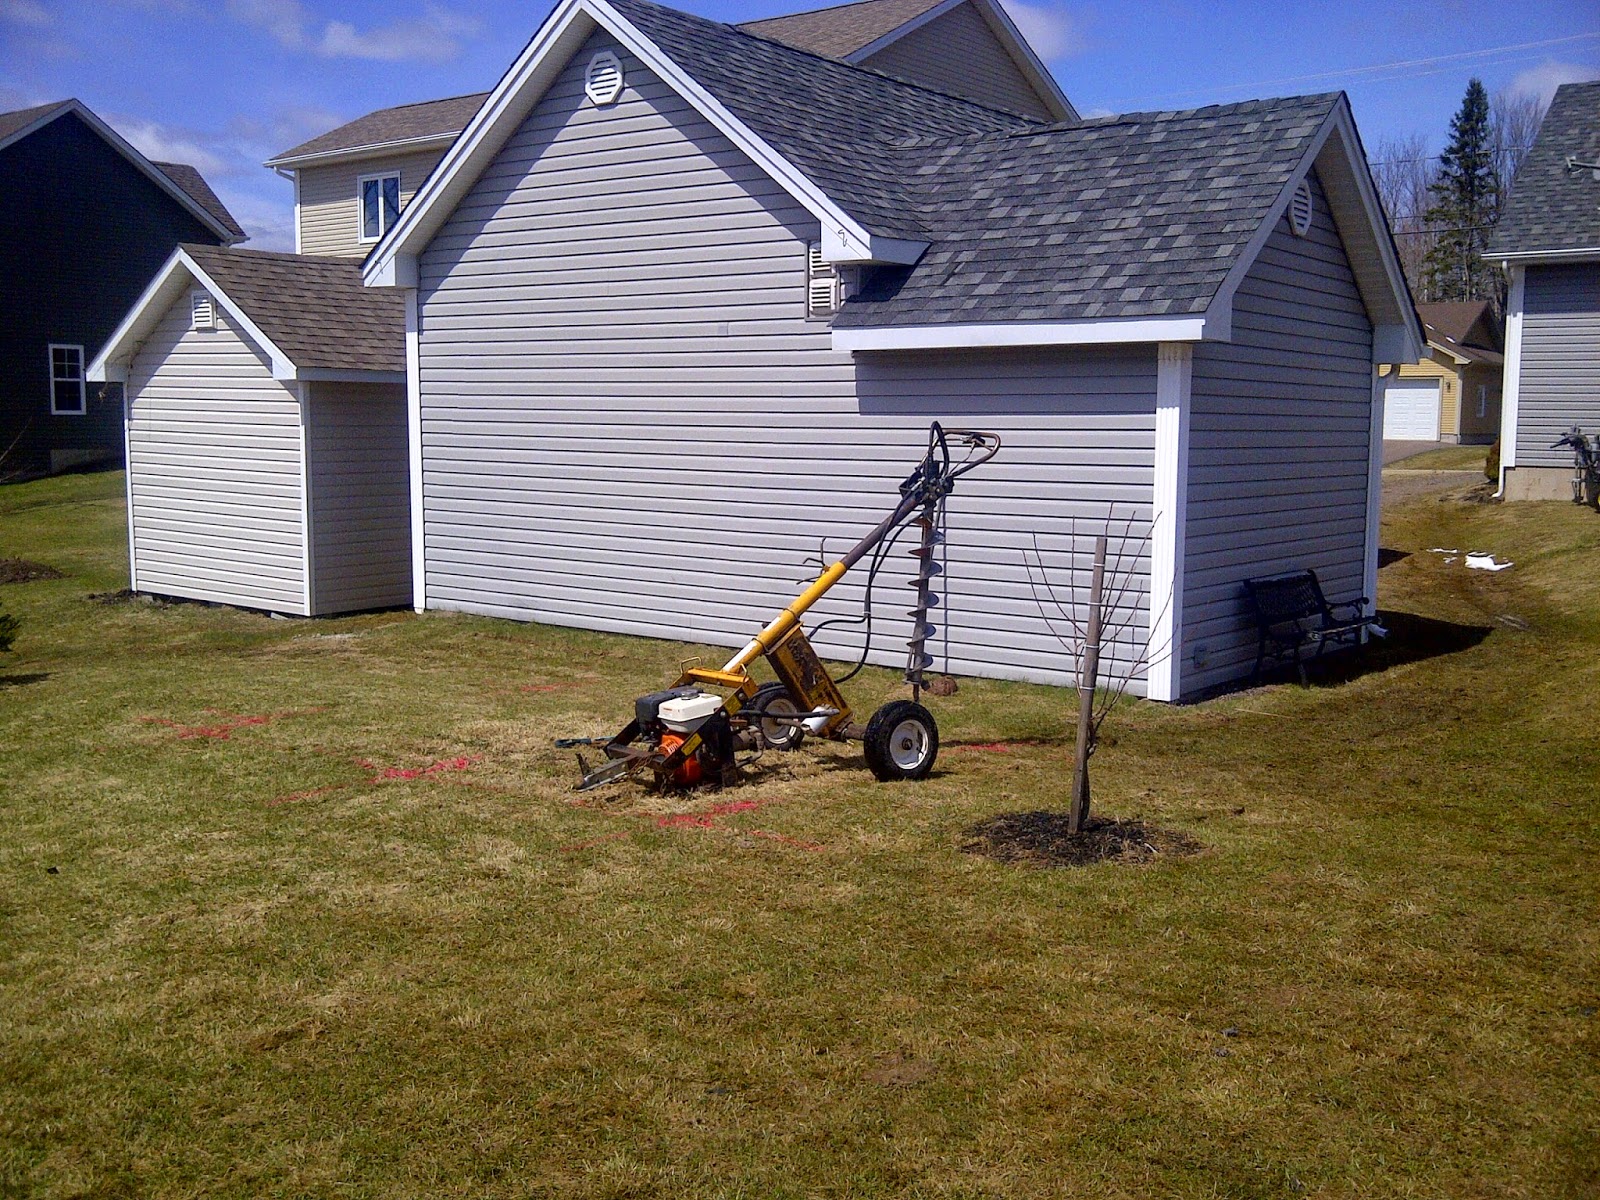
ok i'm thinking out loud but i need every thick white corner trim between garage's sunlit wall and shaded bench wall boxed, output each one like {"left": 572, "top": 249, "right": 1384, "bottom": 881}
{"left": 1144, "top": 342, "right": 1194, "bottom": 701}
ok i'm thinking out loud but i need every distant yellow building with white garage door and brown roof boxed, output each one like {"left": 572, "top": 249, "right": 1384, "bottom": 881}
{"left": 1384, "top": 301, "right": 1506, "bottom": 445}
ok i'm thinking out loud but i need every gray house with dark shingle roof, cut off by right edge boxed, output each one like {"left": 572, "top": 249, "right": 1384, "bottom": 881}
{"left": 1485, "top": 83, "right": 1600, "bottom": 499}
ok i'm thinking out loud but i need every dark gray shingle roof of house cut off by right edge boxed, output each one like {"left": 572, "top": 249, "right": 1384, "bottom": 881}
{"left": 1488, "top": 82, "right": 1600, "bottom": 254}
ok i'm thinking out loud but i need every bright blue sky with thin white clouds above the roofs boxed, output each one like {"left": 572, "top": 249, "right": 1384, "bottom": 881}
{"left": 0, "top": 0, "right": 1600, "bottom": 250}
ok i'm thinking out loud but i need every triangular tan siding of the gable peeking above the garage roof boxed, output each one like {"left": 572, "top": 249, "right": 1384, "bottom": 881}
{"left": 861, "top": 5, "right": 1053, "bottom": 120}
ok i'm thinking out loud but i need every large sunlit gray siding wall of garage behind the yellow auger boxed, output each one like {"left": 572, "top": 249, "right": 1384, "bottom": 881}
{"left": 419, "top": 35, "right": 1155, "bottom": 691}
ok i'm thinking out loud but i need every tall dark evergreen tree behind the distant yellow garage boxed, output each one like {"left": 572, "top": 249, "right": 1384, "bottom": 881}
{"left": 1424, "top": 80, "right": 1499, "bottom": 301}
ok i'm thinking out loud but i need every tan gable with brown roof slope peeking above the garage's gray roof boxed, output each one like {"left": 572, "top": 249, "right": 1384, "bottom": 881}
{"left": 739, "top": 0, "right": 1078, "bottom": 123}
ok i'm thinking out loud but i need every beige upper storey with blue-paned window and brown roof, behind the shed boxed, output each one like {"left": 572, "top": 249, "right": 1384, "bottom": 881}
{"left": 267, "top": 93, "right": 483, "bottom": 258}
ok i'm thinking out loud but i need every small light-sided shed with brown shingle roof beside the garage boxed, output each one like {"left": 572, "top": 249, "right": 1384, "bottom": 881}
{"left": 93, "top": 246, "right": 411, "bottom": 616}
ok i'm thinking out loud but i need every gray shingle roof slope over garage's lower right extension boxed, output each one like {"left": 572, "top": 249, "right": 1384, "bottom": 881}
{"left": 835, "top": 94, "right": 1342, "bottom": 328}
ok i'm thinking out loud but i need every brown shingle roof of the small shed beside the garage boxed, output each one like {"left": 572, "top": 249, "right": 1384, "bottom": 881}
{"left": 182, "top": 245, "right": 405, "bottom": 371}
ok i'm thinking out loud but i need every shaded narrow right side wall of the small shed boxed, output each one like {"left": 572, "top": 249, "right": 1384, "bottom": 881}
{"left": 306, "top": 382, "right": 411, "bottom": 616}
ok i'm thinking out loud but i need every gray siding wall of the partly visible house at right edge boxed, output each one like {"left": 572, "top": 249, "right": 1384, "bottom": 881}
{"left": 1517, "top": 262, "right": 1600, "bottom": 467}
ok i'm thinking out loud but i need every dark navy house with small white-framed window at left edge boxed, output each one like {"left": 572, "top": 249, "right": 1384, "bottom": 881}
{"left": 0, "top": 99, "right": 245, "bottom": 478}
